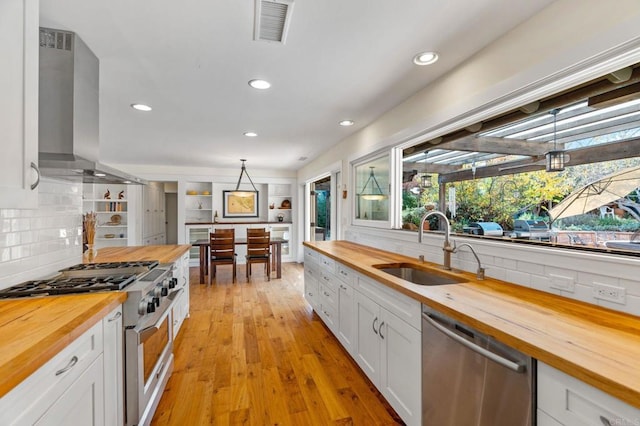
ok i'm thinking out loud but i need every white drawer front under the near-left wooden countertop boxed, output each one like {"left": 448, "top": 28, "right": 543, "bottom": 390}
{"left": 0, "top": 321, "right": 103, "bottom": 425}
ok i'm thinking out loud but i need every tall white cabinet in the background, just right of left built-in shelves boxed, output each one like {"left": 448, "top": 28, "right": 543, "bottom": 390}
{"left": 142, "top": 182, "right": 167, "bottom": 246}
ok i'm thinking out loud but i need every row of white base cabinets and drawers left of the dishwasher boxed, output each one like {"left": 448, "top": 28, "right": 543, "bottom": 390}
{"left": 304, "top": 247, "right": 422, "bottom": 425}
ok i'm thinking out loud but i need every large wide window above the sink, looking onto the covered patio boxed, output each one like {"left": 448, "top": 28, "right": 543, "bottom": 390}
{"left": 398, "top": 64, "right": 640, "bottom": 255}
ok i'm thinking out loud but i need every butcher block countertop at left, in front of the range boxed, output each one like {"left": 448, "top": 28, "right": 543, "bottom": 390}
{"left": 0, "top": 292, "right": 127, "bottom": 397}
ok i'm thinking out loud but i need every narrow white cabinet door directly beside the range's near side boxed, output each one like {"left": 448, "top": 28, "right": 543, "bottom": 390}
{"left": 103, "top": 306, "right": 124, "bottom": 425}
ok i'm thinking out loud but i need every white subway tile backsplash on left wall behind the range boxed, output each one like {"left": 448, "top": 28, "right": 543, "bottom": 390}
{"left": 0, "top": 179, "right": 82, "bottom": 288}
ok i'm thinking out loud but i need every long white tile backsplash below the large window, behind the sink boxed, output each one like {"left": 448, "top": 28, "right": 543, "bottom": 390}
{"left": 345, "top": 226, "right": 640, "bottom": 316}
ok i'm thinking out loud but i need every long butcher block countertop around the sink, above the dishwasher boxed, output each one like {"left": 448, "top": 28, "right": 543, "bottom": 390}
{"left": 304, "top": 241, "right": 640, "bottom": 408}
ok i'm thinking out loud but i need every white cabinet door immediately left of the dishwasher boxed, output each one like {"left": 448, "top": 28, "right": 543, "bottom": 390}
{"left": 379, "top": 308, "right": 422, "bottom": 425}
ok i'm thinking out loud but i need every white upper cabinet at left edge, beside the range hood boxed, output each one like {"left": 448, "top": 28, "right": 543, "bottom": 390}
{"left": 0, "top": 0, "right": 39, "bottom": 209}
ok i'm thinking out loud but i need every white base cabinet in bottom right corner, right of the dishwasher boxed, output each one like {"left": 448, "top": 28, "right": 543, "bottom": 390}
{"left": 537, "top": 362, "right": 640, "bottom": 426}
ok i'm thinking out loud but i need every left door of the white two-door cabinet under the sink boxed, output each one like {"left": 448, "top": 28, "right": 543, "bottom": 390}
{"left": 355, "top": 292, "right": 381, "bottom": 386}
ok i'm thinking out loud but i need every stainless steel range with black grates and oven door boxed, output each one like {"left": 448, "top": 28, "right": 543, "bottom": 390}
{"left": 0, "top": 261, "right": 184, "bottom": 426}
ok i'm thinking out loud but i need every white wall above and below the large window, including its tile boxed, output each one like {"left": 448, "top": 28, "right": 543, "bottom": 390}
{"left": 298, "top": 0, "right": 640, "bottom": 315}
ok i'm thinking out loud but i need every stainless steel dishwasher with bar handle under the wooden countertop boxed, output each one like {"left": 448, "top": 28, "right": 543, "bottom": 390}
{"left": 422, "top": 305, "right": 535, "bottom": 426}
